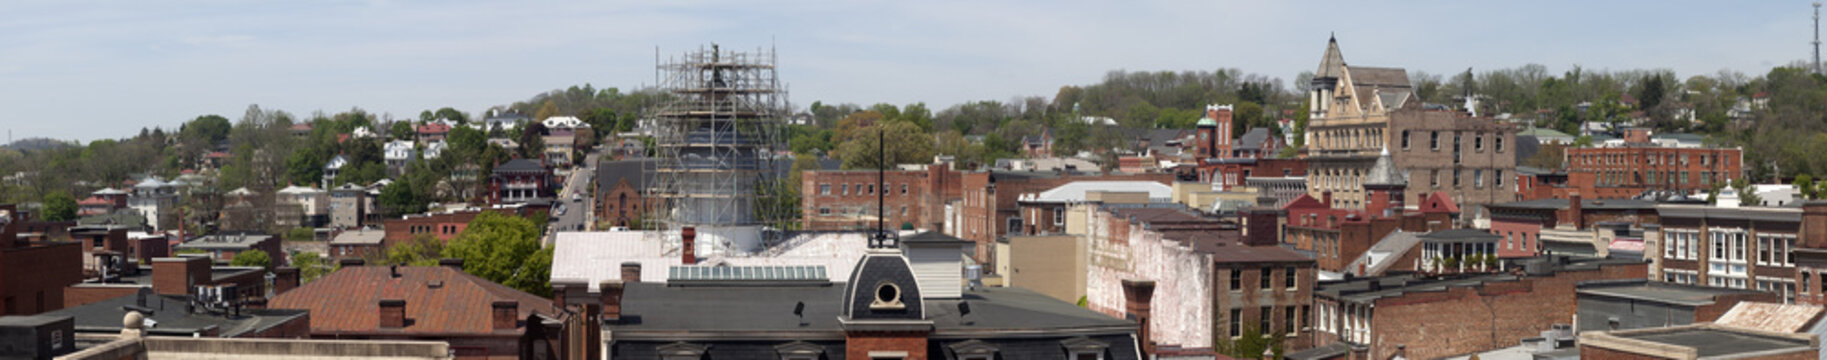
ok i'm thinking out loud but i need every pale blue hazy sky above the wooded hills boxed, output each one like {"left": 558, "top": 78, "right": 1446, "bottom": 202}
{"left": 0, "top": 0, "right": 1812, "bottom": 141}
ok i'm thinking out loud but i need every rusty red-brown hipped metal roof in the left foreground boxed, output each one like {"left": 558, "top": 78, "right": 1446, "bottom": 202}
{"left": 267, "top": 267, "right": 554, "bottom": 336}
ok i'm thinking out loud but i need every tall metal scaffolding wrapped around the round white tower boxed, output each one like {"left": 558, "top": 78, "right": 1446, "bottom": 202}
{"left": 645, "top": 44, "right": 787, "bottom": 247}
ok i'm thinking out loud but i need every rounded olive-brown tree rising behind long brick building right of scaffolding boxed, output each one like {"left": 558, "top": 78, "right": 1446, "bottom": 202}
{"left": 833, "top": 121, "right": 934, "bottom": 168}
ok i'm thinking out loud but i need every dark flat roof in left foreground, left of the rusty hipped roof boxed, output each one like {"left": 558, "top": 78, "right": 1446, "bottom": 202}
{"left": 44, "top": 291, "right": 309, "bottom": 338}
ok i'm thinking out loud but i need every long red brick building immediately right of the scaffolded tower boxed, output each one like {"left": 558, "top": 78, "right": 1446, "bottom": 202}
{"left": 798, "top": 163, "right": 963, "bottom": 230}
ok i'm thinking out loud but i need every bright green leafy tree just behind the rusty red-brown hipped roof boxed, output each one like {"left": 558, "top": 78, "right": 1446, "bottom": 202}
{"left": 442, "top": 212, "right": 552, "bottom": 296}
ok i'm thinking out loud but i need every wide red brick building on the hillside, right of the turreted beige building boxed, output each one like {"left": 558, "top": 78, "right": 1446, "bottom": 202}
{"left": 1566, "top": 130, "right": 1745, "bottom": 199}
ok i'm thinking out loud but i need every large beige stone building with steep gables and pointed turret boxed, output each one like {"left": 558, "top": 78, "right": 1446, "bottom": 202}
{"left": 1306, "top": 38, "right": 1516, "bottom": 219}
